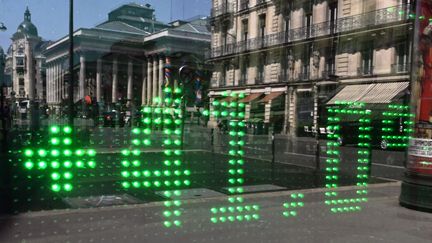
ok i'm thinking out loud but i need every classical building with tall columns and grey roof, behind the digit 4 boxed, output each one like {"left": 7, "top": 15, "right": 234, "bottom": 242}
{"left": 44, "top": 4, "right": 211, "bottom": 112}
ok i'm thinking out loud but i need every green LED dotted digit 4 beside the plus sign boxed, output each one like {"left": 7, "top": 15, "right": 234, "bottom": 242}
{"left": 120, "top": 80, "right": 192, "bottom": 227}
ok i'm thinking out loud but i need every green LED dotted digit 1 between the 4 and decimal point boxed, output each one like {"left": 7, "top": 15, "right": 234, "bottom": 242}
{"left": 210, "top": 92, "right": 260, "bottom": 223}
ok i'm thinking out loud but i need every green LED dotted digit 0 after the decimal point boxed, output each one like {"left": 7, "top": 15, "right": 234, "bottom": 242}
{"left": 325, "top": 101, "right": 372, "bottom": 213}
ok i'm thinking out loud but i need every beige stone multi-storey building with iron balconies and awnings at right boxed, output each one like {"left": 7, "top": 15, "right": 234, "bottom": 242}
{"left": 208, "top": 0, "right": 413, "bottom": 136}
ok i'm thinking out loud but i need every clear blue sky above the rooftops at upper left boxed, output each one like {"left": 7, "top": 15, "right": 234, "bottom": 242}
{"left": 0, "top": 0, "right": 211, "bottom": 49}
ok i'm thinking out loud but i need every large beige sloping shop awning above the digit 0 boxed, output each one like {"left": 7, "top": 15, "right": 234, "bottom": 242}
{"left": 327, "top": 82, "right": 409, "bottom": 105}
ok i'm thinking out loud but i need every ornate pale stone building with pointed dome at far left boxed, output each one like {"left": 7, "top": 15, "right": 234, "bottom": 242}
{"left": 5, "top": 8, "right": 50, "bottom": 102}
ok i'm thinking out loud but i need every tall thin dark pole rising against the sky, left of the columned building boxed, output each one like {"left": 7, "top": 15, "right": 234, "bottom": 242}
{"left": 68, "top": 0, "right": 74, "bottom": 127}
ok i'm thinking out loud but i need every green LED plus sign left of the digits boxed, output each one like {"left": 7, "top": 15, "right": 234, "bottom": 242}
{"left": 23, "top": 125, "right": 96, "bottom": 192}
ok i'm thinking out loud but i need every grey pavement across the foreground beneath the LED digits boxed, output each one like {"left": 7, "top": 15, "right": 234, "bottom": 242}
{"left": 0, "top": 183, "right": 432, "bottom": 243}
